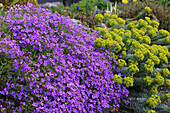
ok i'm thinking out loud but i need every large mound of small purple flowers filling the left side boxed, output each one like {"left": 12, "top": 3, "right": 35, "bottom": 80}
{"left": 0, "top": 4, "right": 129, "bottom": 113}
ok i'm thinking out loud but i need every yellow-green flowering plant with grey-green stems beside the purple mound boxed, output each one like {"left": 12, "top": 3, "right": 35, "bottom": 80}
{"left": 94, "top": 11, "right": 170, "bottom": 113}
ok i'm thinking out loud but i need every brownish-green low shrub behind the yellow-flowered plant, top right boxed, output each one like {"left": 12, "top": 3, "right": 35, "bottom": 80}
{"left": 118, "top": 0, "right": 170, "bottom": 32}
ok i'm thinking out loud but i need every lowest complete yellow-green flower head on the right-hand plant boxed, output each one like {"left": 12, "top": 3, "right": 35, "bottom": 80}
{"left": 146, "top": 94, "right": 161, "bottom": 108}
